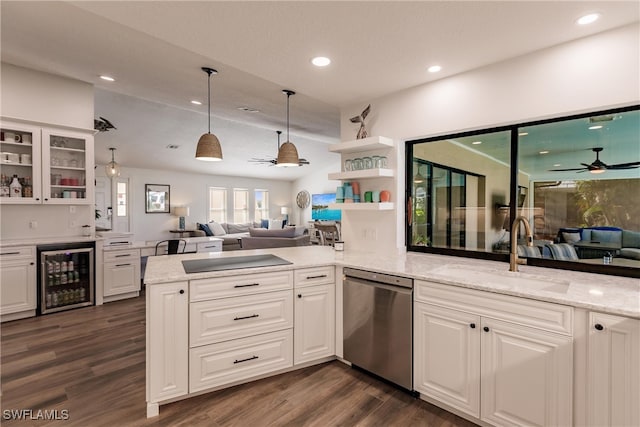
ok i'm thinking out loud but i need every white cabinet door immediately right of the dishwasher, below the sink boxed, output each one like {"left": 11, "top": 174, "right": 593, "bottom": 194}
{"left": 413, "top": 304, "right": 481, "bottom": 418}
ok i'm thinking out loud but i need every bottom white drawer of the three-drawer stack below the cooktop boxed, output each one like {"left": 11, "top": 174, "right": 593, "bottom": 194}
{"left": 189, "top": 329, "right": 293, "bottom": 393}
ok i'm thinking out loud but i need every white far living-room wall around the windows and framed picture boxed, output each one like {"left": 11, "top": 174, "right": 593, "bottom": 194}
{"left": 96, "top": 165, "right": 295, "bottom": 240}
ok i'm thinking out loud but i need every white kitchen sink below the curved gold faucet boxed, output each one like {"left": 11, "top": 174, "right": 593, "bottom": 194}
{"left": 432, "top": 264, "right": 570, "bottom": 293}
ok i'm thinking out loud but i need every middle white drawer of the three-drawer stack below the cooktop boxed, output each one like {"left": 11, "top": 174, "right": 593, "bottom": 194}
{"left": 189, "top": 290, "right": 293, "bottom": 347}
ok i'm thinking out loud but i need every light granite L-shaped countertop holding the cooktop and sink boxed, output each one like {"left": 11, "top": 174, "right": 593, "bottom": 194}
{"left": 144, "top": 246, "right": 640, "bottom": 319}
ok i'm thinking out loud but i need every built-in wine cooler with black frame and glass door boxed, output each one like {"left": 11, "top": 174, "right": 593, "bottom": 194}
{"left": 38, "top": 242, "right": 95, "bottom": 314}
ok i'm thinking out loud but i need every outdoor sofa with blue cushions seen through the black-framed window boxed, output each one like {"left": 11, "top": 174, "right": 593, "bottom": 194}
{"left": 556, "top": 227, "right": 640, "bottom": 260}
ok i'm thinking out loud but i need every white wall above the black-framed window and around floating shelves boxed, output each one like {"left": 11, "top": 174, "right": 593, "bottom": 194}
{"left": 341, "top": 24, "right": 640, "bottom": 251}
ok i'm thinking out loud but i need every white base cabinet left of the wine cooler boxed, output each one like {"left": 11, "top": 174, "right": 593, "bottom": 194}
{"left": 0, "top": 246, "right": 36, "bottom": 321}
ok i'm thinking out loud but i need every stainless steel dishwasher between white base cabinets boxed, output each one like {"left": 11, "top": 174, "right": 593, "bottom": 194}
{"left": 343, "top": 268, "right": 413, "bottom": 391}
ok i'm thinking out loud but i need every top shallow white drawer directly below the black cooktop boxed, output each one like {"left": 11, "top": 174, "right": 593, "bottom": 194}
{"left": 189, "top": 271, "right": 293, "bottom": 302}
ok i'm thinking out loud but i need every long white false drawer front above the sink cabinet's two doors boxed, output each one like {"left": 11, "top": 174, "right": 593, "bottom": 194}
{"left": 415, "top": 280, "right": 573, "bottom": 335}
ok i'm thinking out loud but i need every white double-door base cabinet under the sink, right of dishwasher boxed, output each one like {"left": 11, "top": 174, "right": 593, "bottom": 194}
{"left": 414, "top": 281, "right": 573, "bottom": 426}
